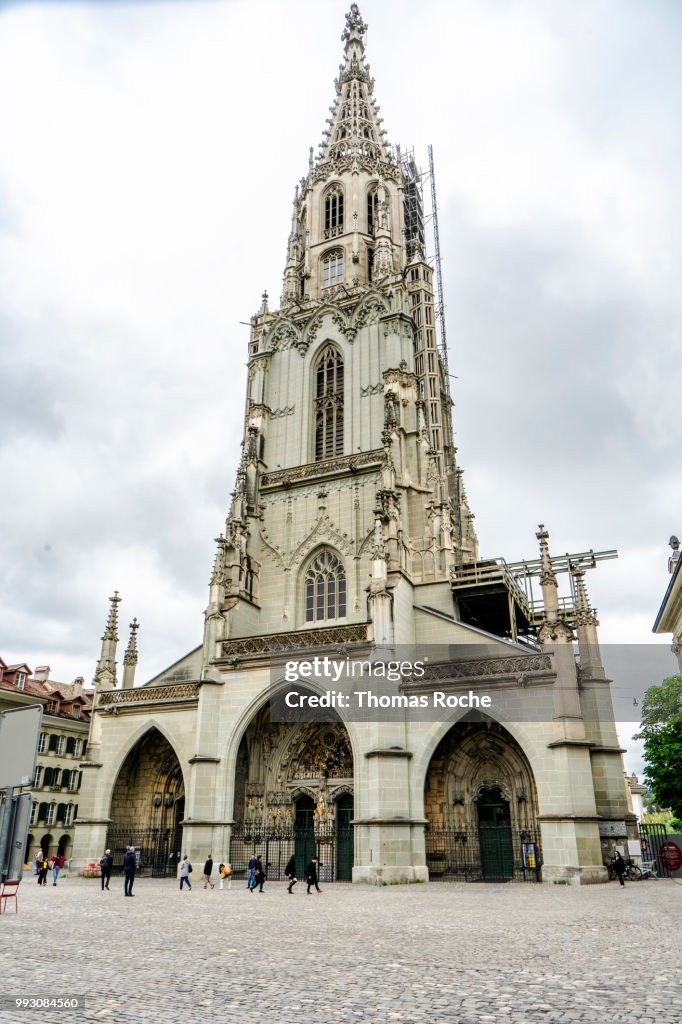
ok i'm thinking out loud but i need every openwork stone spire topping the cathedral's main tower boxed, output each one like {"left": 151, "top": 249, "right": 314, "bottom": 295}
{"left": 319, "top": 4, "right": 391, "bottom": 161}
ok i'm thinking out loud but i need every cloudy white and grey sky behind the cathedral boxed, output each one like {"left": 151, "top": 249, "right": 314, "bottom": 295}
{"left": 0, "top": 0, "right": 682, "bottom": 770}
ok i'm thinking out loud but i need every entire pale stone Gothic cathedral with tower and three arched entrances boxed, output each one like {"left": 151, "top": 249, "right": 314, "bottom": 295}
{"left": 72, "top": 4, "right": 635, "bottom": 885}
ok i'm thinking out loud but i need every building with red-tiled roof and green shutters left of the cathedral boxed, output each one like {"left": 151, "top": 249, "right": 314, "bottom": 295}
{"left": 0, "top": 658, "right": 92, "bottom": 860}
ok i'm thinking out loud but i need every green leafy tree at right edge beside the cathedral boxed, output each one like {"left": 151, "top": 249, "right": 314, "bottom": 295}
{"left": 635, "top": 676, "right": 682, "bottom": 818}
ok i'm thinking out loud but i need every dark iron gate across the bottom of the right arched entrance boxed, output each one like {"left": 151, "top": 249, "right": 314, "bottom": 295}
{"left": 425, "top": 825, "right": 542, "bottom": 882}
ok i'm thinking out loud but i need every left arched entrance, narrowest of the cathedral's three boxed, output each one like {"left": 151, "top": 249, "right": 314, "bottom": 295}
{"left": 106, "top": 729, "right": 184, "bottom": 878}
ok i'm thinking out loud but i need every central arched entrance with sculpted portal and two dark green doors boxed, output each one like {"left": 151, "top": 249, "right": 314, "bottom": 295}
{"left": 229, "top": 703, "right": 354, "bottom": 882}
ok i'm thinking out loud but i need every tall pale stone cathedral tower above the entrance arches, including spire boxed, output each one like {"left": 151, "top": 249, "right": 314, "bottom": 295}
{"left": 204, "top": 4, "right": 476, "bottom": 664}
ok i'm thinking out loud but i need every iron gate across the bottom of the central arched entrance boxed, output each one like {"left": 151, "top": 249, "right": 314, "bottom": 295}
{"left": 229, "top": 824, "right": 353, "bottom": 882}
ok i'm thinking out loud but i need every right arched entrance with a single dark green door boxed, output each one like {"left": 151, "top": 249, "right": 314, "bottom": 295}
{"left": 424, "top": 721, "right": 542, "bottom": 882}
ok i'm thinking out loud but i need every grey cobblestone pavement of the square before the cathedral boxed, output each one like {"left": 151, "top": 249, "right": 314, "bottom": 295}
{"left": 0, "top": 877, "right": 682, "bottom": 1024}
